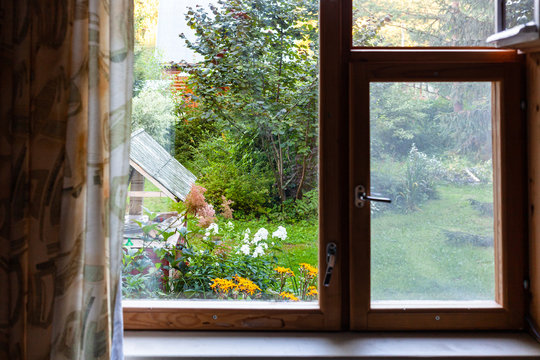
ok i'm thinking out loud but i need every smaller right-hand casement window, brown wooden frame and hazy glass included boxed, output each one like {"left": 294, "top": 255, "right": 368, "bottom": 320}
{"left": 349, "top": 49, "right": 526, "bottom": 330}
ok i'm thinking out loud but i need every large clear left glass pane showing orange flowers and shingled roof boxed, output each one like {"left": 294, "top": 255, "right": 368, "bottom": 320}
{"left": 123, "top": 0, "right": 319, "bottom": 302}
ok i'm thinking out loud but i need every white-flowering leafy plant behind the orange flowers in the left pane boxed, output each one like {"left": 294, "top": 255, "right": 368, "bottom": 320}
{"left": 151, "top": 212, "right": 288, "bottom": 299}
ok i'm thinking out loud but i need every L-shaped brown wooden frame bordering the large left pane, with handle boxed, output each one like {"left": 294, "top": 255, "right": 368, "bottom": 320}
{"left": 123, "top": 0, "right": 349, "bottom": 331}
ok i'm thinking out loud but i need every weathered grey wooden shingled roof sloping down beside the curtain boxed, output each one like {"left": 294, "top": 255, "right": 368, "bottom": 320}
{"left": 129, "top": 129, "right": 197, "bottom": 201}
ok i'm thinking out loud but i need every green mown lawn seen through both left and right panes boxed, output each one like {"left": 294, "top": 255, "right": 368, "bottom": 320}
{"left": 129, "top": 178, "right": 495, "bottom": 300}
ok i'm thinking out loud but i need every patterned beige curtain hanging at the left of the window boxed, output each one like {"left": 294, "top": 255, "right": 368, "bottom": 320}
{"left": 0, "top": 0, "right": 133, "bottom": 359}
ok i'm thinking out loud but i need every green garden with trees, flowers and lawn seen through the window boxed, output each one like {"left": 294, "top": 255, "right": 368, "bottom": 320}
{"left": 122, "top": 0, "right": 495, "bottom": 301}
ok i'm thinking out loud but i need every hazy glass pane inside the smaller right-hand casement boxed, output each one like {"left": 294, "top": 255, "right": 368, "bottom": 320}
{"left": 370, "top": 82, "right": 495, "bottom": 304}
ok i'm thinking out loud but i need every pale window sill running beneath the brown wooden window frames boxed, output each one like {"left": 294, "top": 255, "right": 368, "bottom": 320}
{"left": 124, "top": 331, "right": 540, "bottom": 360}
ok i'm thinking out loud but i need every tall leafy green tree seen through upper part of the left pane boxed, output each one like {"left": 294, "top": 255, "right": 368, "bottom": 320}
{"left": 179, "top": 0, "right": 318, "bottom": 202}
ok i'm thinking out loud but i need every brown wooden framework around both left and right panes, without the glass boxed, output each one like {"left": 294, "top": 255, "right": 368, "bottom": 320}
{"left": 124, "top": 0, "right": 527, "bottom": 331}
